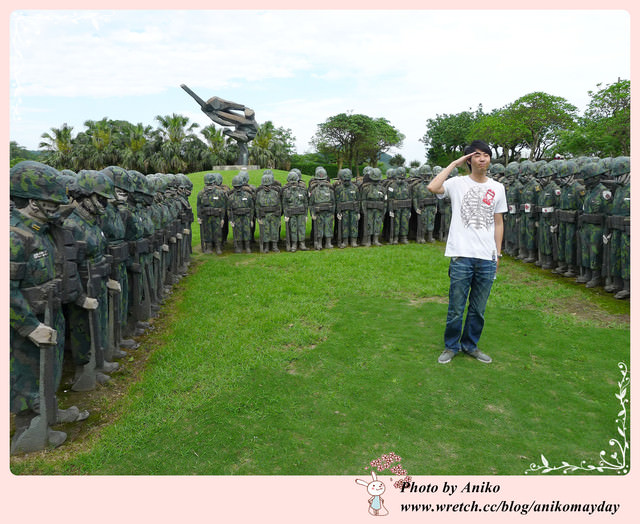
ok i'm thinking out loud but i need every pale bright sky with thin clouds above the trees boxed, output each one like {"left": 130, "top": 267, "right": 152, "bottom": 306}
{"left": 9, "top": 9, "right": 631, "bottom": 162}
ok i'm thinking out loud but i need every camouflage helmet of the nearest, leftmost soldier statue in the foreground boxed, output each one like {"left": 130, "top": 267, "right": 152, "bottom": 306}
{"left": 9, "top": 160, "right": 69, "bottom": 204}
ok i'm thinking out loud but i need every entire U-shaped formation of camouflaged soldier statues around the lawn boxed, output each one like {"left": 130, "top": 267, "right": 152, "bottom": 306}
{"left": 10, "top": 157, "right": 631, "bottom": 453}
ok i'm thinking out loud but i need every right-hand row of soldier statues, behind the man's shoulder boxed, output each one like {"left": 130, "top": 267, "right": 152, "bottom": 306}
{"left": 492, "top": 156, "right": 631, "bottom": 299}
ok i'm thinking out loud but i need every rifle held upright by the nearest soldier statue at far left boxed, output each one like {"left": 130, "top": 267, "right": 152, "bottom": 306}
{"left": 11, "top": 286, "right": 57, "bottom": 454}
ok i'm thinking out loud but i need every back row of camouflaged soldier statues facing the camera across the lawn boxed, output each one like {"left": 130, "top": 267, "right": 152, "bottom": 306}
{"left": 197, "top": 166, "right": 450, "bottom": 254}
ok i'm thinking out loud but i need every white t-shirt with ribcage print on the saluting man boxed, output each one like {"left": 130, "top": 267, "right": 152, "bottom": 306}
{"left": 437, "top": 175, "right": 507, "bottom": 260}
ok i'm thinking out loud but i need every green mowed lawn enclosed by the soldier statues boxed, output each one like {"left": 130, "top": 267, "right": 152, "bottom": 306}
{"left": 12, "top": 243, "right": 629, "bottom": 475}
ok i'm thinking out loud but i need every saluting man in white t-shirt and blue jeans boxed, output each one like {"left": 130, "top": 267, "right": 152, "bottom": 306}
{"left": 428, "top": 140, "right": 507, "bottom": 364}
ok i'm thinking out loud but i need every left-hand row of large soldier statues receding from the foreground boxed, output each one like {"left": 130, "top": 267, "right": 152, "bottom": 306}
{"left": 10, "top": 161, "right": 193, "bottom": 454}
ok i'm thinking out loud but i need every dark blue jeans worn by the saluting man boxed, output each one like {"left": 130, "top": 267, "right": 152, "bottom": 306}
{"left": 444, "top": 257, "right": 497, "bottom": 353}
